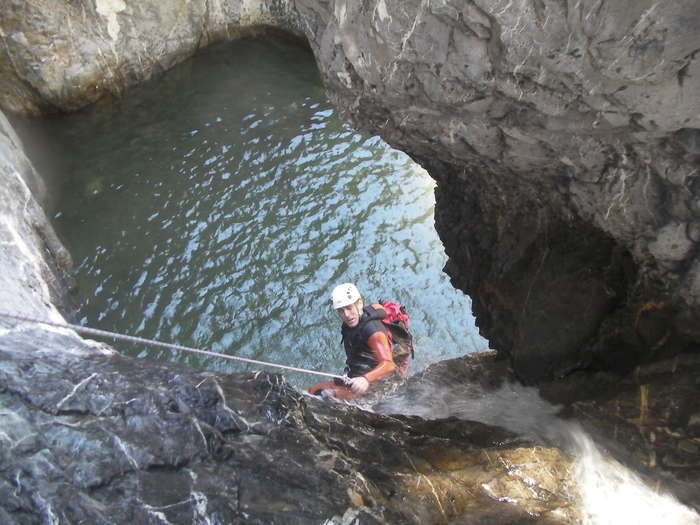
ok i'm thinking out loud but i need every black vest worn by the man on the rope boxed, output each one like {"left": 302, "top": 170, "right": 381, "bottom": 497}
{"left": 340, "top": 306, "right": 386, "bottom": 377}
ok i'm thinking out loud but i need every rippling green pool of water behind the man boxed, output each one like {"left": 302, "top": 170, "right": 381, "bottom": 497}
{"left": 27, "top": 34, "right": 487, "bottom": 385}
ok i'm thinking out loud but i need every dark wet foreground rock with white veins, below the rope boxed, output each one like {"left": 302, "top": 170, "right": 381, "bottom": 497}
{"left": 0, "top": 325, "right": 580, "bottom": 524}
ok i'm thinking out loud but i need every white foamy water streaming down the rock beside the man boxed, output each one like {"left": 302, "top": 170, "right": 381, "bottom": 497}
{"left": 375, "top": 382, "right": 700, "bottom": 525}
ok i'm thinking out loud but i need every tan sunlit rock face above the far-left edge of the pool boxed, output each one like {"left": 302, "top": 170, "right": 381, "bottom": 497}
{"left": 0, "top": 0, "right": 298, "bottom": 115}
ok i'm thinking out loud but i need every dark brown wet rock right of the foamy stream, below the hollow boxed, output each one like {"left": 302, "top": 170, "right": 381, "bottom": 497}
{"left": 540, "top": 355, "right": 700, "bottom": 509}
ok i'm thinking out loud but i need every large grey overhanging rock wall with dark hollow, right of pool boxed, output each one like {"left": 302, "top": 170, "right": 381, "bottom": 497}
{"left": 297, "top": 0, "right": 700, "bottom": 382}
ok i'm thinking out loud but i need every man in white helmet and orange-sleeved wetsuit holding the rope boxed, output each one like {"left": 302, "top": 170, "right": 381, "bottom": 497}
{"left": 308, "top": 283, "right": 408, "bottom": 400}
